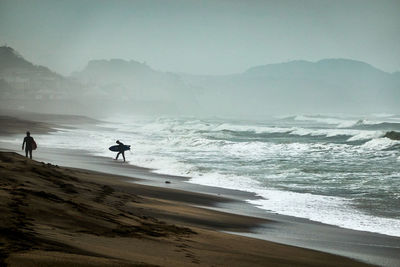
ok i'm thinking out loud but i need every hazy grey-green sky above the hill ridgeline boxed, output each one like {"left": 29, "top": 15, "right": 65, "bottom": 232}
{"left": 0, "top": 0, "right": 400, "bottom": 74}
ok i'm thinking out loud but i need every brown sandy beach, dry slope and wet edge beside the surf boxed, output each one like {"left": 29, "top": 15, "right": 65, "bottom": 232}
{"left": 0, "top": 114, "right": 400, "bottom": 266}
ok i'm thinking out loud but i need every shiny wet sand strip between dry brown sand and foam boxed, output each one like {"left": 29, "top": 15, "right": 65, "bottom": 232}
{"left": 0, "top": 114, "right": 400, "bottom": 266}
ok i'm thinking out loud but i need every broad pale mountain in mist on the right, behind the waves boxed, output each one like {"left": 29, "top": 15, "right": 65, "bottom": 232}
{"left": 182, "top": 59, "right": 400, "bottom": 116}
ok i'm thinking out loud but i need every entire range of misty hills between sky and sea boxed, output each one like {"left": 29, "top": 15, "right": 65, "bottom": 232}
{"left": 0, "top": 47, "right": 400, "bottom": 117}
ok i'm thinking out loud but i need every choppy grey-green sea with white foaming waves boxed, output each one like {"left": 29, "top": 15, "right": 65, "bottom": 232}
{"left": 6, "top": 114, "right": 400, "bottom": 236}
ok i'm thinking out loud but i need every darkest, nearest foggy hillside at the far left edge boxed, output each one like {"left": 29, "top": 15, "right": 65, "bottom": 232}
{"left": 0, "top": 46, "right": 81, "bottom": 113}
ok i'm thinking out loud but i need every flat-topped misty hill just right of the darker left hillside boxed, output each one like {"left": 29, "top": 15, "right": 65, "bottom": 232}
{"left": 72, "top": 59, "right": 198, "bottom": 114}
